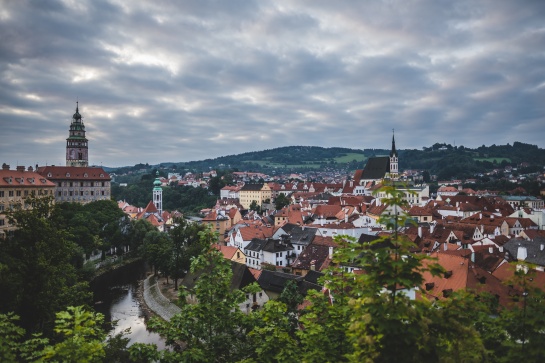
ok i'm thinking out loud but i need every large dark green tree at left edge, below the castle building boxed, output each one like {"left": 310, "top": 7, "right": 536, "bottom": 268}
{"left": 0, "top": 197, "right": 91, "bottom": 332}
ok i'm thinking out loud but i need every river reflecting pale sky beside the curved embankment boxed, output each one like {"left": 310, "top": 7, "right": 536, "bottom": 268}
{"left": 93, "top": 263, "right": 165, "bottom": 350}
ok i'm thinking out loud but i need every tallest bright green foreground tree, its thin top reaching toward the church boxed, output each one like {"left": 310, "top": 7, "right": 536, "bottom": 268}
{"left": 299, "top": 186, "right": 452, "bottom": 362}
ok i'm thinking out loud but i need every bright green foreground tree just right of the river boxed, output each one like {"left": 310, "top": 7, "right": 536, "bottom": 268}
{"left": 130, "top": 231, "right": 258, "bottom": 362}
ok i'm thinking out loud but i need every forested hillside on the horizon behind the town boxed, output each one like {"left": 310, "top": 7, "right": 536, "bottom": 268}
{"left": 110, "top": 142, "right": 545, "bottom": 179}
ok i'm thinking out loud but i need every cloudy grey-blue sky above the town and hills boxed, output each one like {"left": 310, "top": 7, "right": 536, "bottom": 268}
{"left": 0, "top": 0, "right": 545, "bottom": 168}
